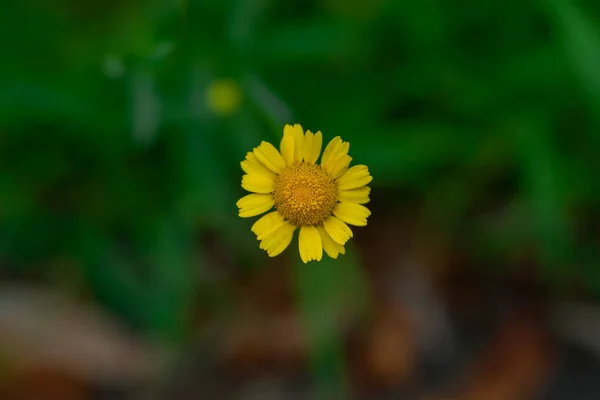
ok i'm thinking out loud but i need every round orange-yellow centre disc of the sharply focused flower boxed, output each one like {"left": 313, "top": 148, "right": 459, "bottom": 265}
{"left": 273, "top": 163, "right": 337, "bottom": 226}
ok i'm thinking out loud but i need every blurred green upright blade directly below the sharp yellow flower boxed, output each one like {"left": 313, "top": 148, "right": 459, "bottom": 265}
{"left": 294, "top": 245, "right": 368, "bottom": 399}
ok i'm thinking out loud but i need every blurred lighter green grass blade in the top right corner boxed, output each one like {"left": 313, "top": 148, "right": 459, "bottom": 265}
{"left": 543, "top": 0, "right": 600, "bottom": 126}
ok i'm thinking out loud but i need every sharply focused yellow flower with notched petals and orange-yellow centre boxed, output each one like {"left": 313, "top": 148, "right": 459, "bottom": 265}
{"left": 237, "top": 124, "right": 373, "bottom": 263}
